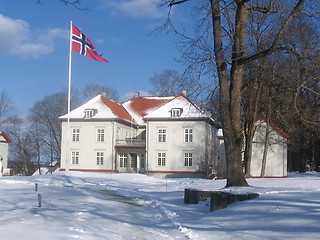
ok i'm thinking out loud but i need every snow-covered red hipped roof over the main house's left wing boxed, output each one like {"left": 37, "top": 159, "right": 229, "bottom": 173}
{"left": 60, "top": 94, "right": 134, "bottom": 122}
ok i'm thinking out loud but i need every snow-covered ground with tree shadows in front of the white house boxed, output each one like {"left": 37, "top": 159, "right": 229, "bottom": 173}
{"left": 0, "top": 172, "right": 320, "bottom": 240}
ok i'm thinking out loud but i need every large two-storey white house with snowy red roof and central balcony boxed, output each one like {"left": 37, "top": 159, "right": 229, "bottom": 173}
{"left": 60, "top": 94, "right": 217, "bottom": 176}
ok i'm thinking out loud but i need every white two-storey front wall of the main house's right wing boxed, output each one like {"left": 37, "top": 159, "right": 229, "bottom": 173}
{"left": 147, "top": 121, "right": 213, "bottom": 175}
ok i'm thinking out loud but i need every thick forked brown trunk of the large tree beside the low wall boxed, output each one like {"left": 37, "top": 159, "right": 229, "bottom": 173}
{"left": 210, "top": 0, "right": 248, "bottom": 187}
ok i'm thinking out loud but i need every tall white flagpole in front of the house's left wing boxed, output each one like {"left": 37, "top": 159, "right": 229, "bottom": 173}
{"left": 66, "top": 21, "right": 72, "bottom": 172}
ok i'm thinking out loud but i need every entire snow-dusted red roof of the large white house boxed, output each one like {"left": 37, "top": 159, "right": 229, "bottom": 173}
{"left": 60, "top": 94, "right": 214, "bottom": 125}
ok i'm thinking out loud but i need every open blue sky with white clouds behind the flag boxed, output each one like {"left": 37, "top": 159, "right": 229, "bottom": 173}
{"left": 0, "top": 0, "right": 188, "bottom": 114}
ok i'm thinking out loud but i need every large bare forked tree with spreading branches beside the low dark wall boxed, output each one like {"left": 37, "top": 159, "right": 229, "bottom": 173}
{"left": 161, "top": 0, "right": 310, "bottom": 186}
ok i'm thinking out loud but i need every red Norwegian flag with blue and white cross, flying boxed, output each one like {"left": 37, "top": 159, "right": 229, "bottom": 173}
{"left": 72, "top": 24, "right": 108, "bottom": 62}
